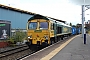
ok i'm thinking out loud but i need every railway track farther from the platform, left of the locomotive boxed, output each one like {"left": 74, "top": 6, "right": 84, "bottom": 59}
{"left": 0, "top": 45, "right": 29, "bottom": 58}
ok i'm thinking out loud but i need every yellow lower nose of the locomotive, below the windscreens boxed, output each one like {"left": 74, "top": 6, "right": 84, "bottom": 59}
{"left": 28, "top": 30, "right": 49, "bottom": 44}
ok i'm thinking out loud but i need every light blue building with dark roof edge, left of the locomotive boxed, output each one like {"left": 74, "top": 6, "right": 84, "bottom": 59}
{"left": 0, "top": 4, "right": 35, "bottom": 29}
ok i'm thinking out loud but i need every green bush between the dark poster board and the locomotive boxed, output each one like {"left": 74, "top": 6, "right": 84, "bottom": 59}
{"left": 5, "top": 29, "right": 27, "bottom": 46}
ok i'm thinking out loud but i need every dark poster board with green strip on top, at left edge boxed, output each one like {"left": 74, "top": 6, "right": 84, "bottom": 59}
{"left": 0, "top": 20, "right": 11, "bottom": 40}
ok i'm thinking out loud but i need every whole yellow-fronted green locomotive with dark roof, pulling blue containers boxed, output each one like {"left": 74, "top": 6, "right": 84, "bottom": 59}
{"left": 26, "top": 14, "right": 72, "bottom": 46}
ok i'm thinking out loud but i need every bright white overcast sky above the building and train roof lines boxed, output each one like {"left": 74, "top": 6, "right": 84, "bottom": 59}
{"left": 0, "top": 0, "right": 90, "bottom": 25}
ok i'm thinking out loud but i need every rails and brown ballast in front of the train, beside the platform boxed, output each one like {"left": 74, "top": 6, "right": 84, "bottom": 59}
{"left": 0, "top": 35, "right": 74, "bottom": 60}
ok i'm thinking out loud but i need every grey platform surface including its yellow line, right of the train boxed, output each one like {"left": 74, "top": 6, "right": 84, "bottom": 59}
{"left": 41, "top": 35, "right": 90, "bottom": 60}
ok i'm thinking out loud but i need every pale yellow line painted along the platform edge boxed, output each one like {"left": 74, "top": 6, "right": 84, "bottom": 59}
{"left": 40, "top": 35, "right": 79, "bottom": 60}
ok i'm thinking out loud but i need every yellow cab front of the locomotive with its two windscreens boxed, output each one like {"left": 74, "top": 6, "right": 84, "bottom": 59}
{"left": 27, "top": 19, "right": 50, "bottom": 45}
